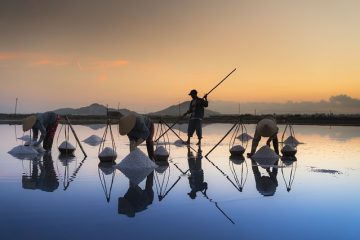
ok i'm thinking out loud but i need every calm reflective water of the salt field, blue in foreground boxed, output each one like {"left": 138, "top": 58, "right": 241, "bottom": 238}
{"left": 0, "top": 124, "right": 360, "bottom": 239}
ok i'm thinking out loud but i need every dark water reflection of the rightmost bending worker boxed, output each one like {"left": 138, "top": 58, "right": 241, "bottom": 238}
{"left": 251, "top": 160, "right": 279, "bottom": 197}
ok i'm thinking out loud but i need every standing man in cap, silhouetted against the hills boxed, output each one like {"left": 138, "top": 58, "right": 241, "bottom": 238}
{"left": 184, "top": 89, "right": 209, "bottom": 146}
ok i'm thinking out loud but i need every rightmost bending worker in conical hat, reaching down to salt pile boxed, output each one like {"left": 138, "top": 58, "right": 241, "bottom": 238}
{"left": 247, "top": 116, "right": 279, "bottom": 157}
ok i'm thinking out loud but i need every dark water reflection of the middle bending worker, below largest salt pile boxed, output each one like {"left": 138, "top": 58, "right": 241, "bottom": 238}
{"left": 118, "top": 171, "right": 154, "bottom": 217}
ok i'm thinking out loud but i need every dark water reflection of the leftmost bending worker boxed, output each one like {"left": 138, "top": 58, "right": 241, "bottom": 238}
{"left": 22, "top": 152, "right": 59, "bottom": 192}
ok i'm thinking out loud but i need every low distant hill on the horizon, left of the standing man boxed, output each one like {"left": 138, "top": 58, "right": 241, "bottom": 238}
{"left": 54, "top": 103, "right": 132, "bottom": 115}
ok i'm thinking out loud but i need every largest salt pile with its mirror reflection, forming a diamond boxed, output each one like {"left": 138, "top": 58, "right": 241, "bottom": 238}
{"left": 116, "top": 149, "right": 157, "bottom": 185}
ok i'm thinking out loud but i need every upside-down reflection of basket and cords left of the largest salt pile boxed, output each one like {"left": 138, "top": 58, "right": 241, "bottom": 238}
{"left": 98, "top": 162, "right": 115, "bottom": 202}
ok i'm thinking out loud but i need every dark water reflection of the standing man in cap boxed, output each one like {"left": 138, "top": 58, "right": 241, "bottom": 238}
{"left": 188, "top": 146, "right": 208, "bottom": 199}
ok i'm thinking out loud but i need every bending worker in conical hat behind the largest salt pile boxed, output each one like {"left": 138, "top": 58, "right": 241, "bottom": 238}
{"left": 119, "top": 114, "right": 154, "bottom": 160}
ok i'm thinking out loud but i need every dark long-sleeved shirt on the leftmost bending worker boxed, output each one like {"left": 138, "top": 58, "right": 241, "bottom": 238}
{"left": 32, "top": 112, "right": 57, "bottom": 144}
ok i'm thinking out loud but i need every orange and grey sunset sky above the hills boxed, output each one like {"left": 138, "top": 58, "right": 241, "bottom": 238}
{"left": 0, "top": 0, "right": 360, "bottom": 113}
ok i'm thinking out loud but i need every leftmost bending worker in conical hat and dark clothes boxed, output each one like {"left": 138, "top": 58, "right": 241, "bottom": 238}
{"left": 22, "top": 112, "right": 60, "bottom": 152}
